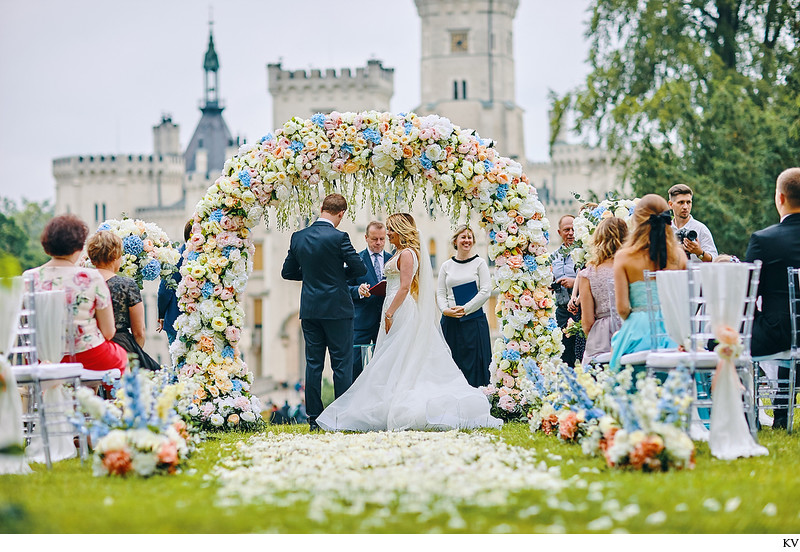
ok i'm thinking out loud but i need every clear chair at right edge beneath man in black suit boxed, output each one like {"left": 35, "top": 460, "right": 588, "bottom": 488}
{"left": 753, "top": 267, "right": 800, "bottom": 434}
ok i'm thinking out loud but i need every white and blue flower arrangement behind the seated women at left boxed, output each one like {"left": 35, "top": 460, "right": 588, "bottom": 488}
{"left": 97, "top": 218, "right": 180, "bottom": 289}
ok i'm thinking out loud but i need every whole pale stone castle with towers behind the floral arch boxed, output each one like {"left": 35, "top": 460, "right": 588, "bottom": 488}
{"left": 53, "top": 0, "right": 621, "bottom": 385}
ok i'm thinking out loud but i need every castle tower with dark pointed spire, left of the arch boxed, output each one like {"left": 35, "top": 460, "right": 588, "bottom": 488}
{"left": 184, "top": 24, "right": 234, "bottom": 175}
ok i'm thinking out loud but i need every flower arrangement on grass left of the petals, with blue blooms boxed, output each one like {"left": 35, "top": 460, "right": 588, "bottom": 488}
{"left": 76, "top": 367, "right": 196, "bottom": 477}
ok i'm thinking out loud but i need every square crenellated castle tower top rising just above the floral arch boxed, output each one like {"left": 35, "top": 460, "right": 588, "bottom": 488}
{"left": 267, "top": 59, "right": 394, "bottom": 128}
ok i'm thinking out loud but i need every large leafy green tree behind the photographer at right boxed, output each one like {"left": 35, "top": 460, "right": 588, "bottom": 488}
{"left": 554, "top": 0, "right": 800, "bottom": 256}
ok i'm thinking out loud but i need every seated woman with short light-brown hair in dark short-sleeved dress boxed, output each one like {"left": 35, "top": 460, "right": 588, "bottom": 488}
{"left": 86, "top": 230, "right": 160, "bottom": 371}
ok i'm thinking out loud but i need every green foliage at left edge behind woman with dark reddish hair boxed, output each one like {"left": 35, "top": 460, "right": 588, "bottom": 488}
{"left": 0, "top": 198, "right": 54, "bottom": 270}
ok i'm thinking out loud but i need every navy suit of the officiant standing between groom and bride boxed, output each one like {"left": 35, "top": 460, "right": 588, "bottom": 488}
{"left": 347, "top": 248, "right": 392, "bottom": 380}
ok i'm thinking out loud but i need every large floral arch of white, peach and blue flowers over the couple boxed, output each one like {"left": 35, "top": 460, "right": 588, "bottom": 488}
{"left": 171, "top": 111, "right": 563, "bottom": 430}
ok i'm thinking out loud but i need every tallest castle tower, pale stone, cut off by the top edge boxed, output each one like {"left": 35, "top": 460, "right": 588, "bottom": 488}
{"left": 414, "top": 0, "right": 525, "bottom": 163}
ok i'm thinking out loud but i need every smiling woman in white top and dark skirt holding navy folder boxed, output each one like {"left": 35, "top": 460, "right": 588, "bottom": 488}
{"left": 436, "top": 225, "right": 492, "bottom": 387}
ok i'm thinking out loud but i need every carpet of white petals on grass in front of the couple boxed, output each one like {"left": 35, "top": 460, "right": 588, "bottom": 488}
{"left": 214, "top": 431, "right": 588, "bottom": 526}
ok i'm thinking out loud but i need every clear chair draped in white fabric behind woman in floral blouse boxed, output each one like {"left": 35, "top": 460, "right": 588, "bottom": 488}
{"left": 9, "top": 279, "right": 87, "bottom": 469}
